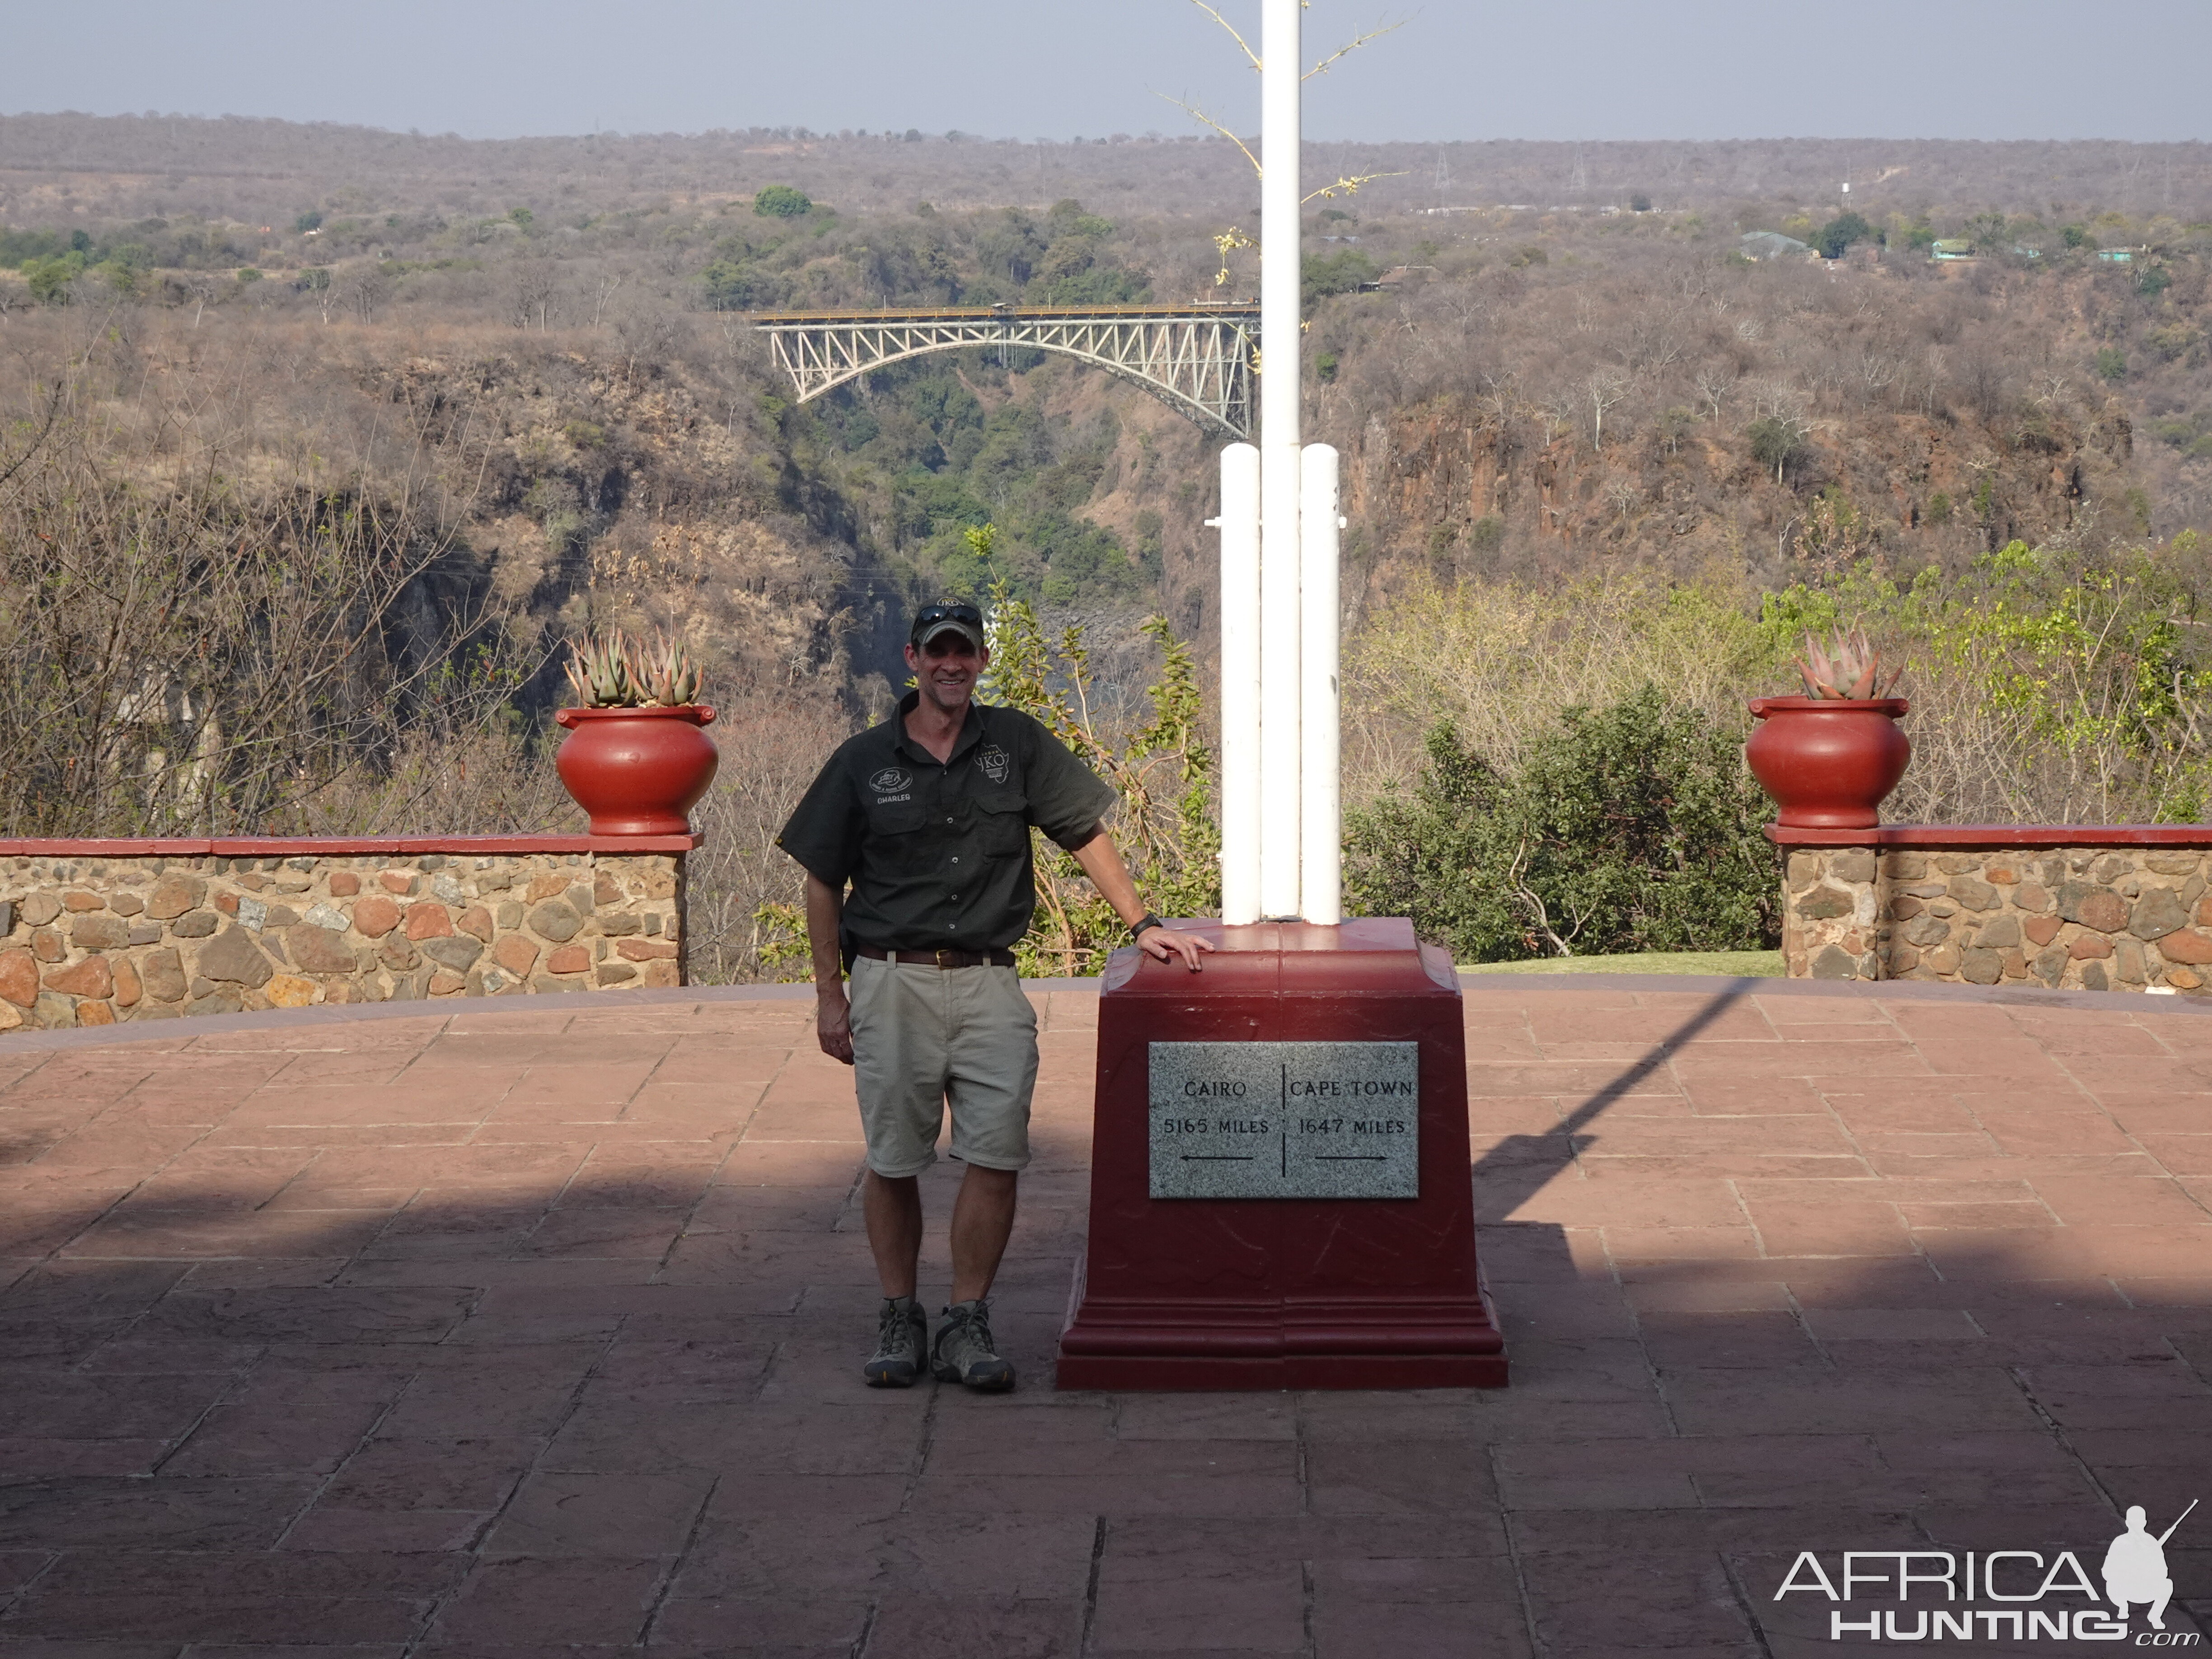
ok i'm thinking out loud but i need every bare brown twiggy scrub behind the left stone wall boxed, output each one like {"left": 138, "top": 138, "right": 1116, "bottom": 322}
{"left": 0, "top": 334, "right": 544, "bottom": 836}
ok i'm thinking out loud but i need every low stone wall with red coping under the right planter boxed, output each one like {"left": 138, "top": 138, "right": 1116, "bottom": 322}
{"left": 1783, "top": 825, "right": 2212, "bottom": 993}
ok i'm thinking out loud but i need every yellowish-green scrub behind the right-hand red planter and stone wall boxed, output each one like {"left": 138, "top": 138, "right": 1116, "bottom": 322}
{"left": 1345, "top": 535, "right": 2212, "bottom": 823}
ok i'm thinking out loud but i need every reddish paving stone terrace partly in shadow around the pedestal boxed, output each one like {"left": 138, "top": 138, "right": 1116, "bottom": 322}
{"left": 0, "top": 978, "right": 2212, "bottom": 1659}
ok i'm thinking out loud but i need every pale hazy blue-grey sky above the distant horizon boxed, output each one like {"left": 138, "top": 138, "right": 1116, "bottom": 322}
{"left": 0, "top": 0, "right": 2212, "bottom": 139}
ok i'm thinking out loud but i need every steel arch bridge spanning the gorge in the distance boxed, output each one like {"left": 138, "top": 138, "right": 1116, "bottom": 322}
{"left": 752, "top": 301, "right": 1259, "bottom": 440}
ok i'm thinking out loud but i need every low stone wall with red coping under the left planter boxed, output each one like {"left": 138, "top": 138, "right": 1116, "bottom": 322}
{"left": 0, "top": 836, "right": 694, "bottom": 1031}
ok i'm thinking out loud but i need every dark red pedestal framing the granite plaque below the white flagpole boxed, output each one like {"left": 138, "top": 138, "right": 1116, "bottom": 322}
{"left": 1057, "top": 918, "right": 1506, "bottom": 1389}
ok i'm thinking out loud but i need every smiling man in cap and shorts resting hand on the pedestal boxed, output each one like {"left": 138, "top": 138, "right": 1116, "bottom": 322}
{"left": 776, "top": 604, "right": 1212, "bottom": 1392}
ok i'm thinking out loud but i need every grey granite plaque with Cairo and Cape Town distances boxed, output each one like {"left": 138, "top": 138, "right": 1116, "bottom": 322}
{"left": 1150, "top": 1042, "right": 1420, "bottom": 1199}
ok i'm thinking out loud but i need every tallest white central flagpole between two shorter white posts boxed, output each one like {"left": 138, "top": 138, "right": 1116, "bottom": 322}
{"left": 1259, "top": 0, "right": 1305, "bottom": 918}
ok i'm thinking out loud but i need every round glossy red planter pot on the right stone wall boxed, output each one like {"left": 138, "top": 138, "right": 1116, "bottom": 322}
{"left": 1743, "top": 697, "right": 1913, "bottom": 830}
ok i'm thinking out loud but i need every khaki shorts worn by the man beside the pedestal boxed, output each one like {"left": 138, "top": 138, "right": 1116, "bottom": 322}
{"left": 849, "top": 956, "right": 1037, "bottom": 1179}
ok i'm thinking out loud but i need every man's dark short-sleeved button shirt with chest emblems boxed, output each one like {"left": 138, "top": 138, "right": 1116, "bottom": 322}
{"left": 776, "top": 692, "right": 1115, "bottom": 951}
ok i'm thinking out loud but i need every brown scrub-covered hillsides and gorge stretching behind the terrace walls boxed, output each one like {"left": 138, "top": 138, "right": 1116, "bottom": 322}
{"left": 0, "top": 117, "right": 2212, "bottom": 975}
